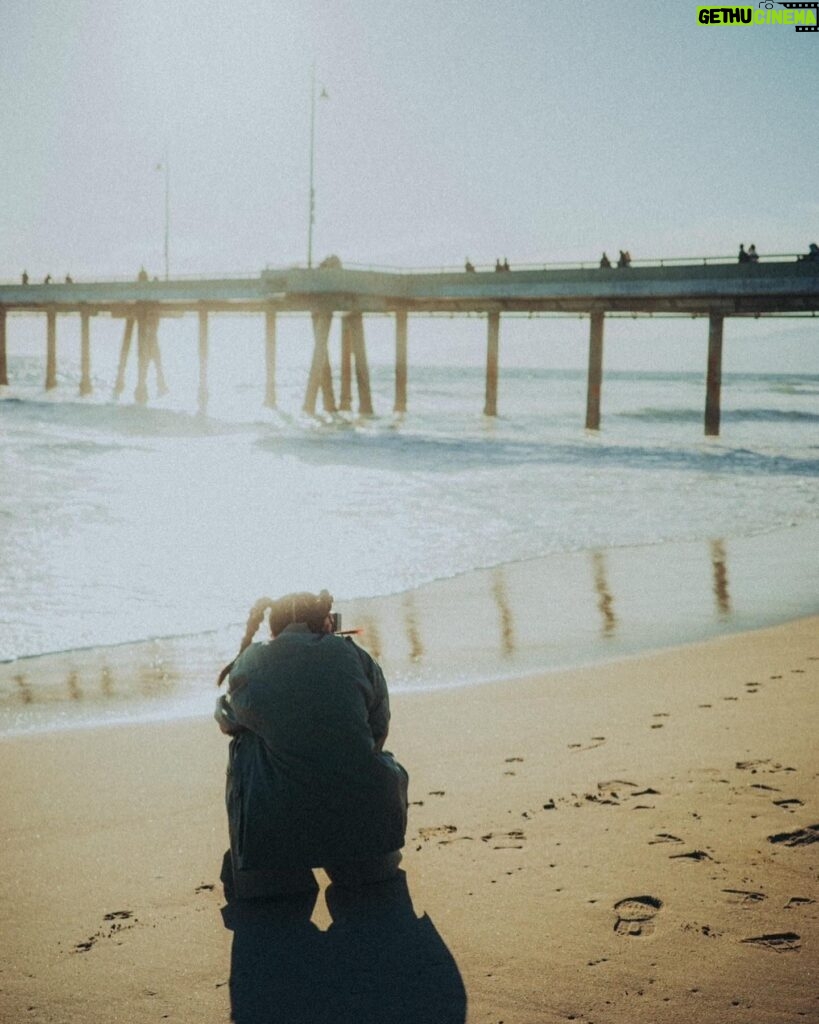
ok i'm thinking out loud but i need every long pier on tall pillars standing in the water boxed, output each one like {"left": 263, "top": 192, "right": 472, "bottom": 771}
{"left": 0, "top": 257, "right": 819, "bottom": 435}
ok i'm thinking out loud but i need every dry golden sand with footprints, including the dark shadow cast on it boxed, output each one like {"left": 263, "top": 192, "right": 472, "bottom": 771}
{"left": 0, "top": 617, "right": 819, "bottom": 1024}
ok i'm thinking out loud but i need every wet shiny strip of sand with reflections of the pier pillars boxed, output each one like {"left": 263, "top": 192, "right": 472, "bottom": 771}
{"left": 0, "top": 522, "right": 819, "bottom": 737}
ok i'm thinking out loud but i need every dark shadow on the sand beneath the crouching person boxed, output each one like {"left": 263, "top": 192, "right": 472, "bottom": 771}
{"left": 222, "top": 871, "right": 467, "bottom": 1024}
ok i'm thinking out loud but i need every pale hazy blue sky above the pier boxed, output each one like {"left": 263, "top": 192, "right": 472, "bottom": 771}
{"left": 0, "top": 0, "right": 819, "bottom": 372}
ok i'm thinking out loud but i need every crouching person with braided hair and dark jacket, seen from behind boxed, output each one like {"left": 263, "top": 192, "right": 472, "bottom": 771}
{"left": 215, "top": 590, "right": 408, "bottom": 899}
